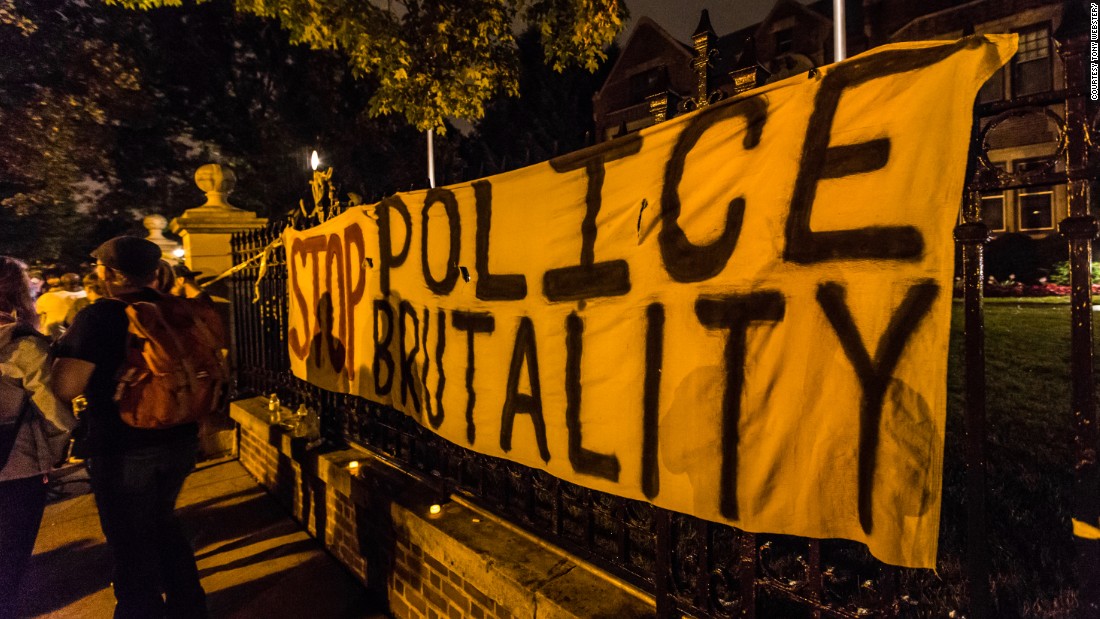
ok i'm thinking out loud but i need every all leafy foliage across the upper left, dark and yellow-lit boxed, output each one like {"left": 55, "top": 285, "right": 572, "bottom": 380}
{"left": 0, "top": 0, "right": 614, "bottom": 268}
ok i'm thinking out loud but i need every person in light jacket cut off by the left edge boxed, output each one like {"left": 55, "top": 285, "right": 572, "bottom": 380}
{"left": 0, "top": 256, "right": 76, "bottom": 619}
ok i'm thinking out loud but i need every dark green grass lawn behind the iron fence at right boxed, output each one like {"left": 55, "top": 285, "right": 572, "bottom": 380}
{"left": 922, "top": 299, "right": 1086, "bottom": 617}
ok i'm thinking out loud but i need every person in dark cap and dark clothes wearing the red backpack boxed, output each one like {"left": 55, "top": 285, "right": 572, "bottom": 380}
{"left": 54, "top": 236, "right": 207, "bottom": 618}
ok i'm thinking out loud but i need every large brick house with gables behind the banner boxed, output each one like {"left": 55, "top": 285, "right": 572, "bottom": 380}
{"left": 593, "top": 0, "right": 1067, "bottom": 239}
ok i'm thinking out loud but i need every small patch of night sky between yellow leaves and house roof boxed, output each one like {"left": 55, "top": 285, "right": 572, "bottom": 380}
{"left": 623, "top": 0, "right": 811, "bottom": 41}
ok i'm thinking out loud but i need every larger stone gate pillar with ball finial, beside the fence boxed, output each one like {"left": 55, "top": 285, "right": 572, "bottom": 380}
{"left": 172, "top": 164, "right": 267, "bottom": 275}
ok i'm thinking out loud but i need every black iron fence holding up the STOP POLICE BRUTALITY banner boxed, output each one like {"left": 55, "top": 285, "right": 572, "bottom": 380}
{"left": 227, "top": 18, "right": 1100, "bottom": 618}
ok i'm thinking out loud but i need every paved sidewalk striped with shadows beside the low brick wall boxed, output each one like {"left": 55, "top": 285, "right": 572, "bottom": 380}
{"left": 21, "top": 461, "right": 385, "bottom": 619}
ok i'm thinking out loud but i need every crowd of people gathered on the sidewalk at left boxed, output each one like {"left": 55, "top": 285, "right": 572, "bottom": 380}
{"left": 0, "top": 236, "right": 224, "bottom": 619}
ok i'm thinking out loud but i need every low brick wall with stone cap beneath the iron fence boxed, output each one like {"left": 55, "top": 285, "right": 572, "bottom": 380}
{"left": 231, "top": 398, "right": 653, "bottom": 619}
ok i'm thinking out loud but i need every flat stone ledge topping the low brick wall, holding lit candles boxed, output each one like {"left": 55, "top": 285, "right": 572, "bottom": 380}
{"left": 231, "top": 397, "right": 655, "bottom": 619}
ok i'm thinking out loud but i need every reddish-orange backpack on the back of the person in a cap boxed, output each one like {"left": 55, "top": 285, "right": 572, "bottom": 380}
{"left": 114, "top": 296, "right": 229, "bottom": 429}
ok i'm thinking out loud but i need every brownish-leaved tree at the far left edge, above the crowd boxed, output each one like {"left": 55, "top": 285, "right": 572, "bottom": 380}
{"left": 0, "top": 0, "right": 154, "bottom": 264}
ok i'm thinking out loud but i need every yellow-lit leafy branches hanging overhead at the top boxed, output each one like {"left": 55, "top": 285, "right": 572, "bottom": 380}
{"left": 102, "top": 0, "right": 626, "bottom": 133}
